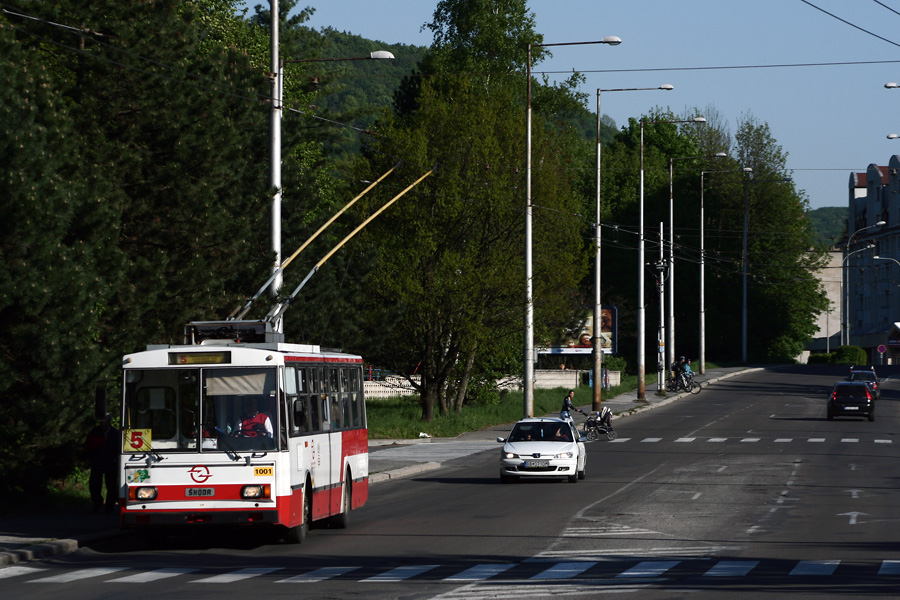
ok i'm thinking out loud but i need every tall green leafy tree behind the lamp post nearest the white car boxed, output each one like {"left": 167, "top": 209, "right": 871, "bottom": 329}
{"left": 356, "top": 1, "right": 585, "bottom": 420}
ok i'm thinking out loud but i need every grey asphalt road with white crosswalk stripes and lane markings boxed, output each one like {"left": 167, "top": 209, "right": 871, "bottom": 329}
{"left": 0, "top": 368, "right": 900, "bottom": 600}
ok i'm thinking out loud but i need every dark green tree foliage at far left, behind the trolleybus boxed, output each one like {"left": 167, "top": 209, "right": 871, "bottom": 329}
{"left": 0, "top": 0, "right": 270, "bottom": 491}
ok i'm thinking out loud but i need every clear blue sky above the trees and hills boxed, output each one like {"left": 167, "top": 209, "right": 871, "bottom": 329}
{"left": 284, "top": 0, "right": 900, "bottom": 209}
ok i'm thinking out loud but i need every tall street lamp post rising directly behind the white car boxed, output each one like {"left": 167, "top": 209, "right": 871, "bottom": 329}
{"left": 522, "top": 35, "right": 622, "bottom": 417}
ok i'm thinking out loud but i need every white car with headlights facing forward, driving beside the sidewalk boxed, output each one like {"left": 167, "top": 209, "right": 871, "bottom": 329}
{"left": 497, "top": 418, "right": 586, "bottom": 483}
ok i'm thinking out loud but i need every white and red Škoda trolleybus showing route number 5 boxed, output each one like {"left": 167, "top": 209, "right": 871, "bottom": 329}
{"left": 120, "top": 321, "right": 369, "bottom": 542}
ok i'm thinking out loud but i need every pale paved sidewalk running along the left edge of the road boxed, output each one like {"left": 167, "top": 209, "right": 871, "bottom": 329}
{"left": 0, "top": 367, "right": 755, "bottom": 567}
